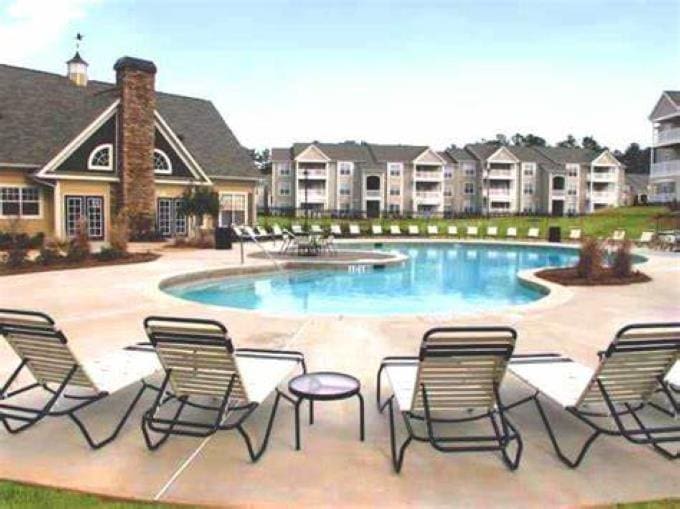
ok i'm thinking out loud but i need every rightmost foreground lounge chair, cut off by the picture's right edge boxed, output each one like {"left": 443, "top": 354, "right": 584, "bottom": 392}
{"left": 507, "top": 322, "right": 680, "bottom": 468}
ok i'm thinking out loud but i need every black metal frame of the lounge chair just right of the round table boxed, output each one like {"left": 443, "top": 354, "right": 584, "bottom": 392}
{"left": 376, "top": 327, "right": 523, "bottom": 473}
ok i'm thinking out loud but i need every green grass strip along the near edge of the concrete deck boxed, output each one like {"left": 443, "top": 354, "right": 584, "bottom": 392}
{"left": 0, "top": 481, "right": 680, "bottom": 509}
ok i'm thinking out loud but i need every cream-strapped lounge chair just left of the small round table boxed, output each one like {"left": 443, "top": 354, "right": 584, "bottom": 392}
{"left": 142, "top": 316, "right": 306, "bottom": 462}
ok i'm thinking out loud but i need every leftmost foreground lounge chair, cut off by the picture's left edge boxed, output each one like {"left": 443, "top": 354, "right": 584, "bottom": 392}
{"left": 0, "top": 309, "right": 160, "bottom": 449}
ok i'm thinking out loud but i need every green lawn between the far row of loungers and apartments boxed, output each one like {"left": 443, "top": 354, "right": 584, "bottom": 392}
{"left": 258, "top": 206, "right": 669, "bottom": 240}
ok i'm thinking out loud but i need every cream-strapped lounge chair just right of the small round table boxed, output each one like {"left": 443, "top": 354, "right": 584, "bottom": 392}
{"left": 377, "top": 327, "right": 522, "bottom": 472}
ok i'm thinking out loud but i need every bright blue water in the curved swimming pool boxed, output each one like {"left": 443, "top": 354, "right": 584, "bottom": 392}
{"left": 166, "top": 243, "right": 578, "bottom": 315}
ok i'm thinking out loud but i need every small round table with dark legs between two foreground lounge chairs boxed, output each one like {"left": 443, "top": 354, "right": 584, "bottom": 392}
{"left": 288, "top": 371, "right": 364, "bottom": 450}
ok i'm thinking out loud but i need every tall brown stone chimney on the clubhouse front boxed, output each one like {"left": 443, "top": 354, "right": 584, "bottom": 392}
{"left": 113, "top": 57, "right": 156, "bottom": 238}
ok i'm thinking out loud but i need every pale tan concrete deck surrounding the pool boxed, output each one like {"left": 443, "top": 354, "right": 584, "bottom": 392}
{"left": 0, "top": 239, "right": 680, "bottom": 507}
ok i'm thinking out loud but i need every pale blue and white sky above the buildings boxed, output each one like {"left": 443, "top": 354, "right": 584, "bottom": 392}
{"left": 0, "top": 0, "right": 680, "bottom": 148}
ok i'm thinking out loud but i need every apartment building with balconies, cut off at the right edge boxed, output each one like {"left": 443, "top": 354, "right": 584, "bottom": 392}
{"left": 649, "top": 90, "right": 680, "bottom": 202}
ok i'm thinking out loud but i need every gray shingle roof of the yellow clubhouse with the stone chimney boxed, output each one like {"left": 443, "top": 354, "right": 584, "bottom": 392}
{"left": 0, "top": 64, "right": 258, "bottom": 178}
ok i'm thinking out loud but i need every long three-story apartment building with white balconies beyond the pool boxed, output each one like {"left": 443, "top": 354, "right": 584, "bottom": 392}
{"left": 272, "top": 142, "right": 624, "bottom": 217}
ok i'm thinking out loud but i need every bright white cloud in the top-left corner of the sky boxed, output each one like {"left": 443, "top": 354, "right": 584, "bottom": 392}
{"left": 0, "top": 0, "right": 99, "bottom": 63}
